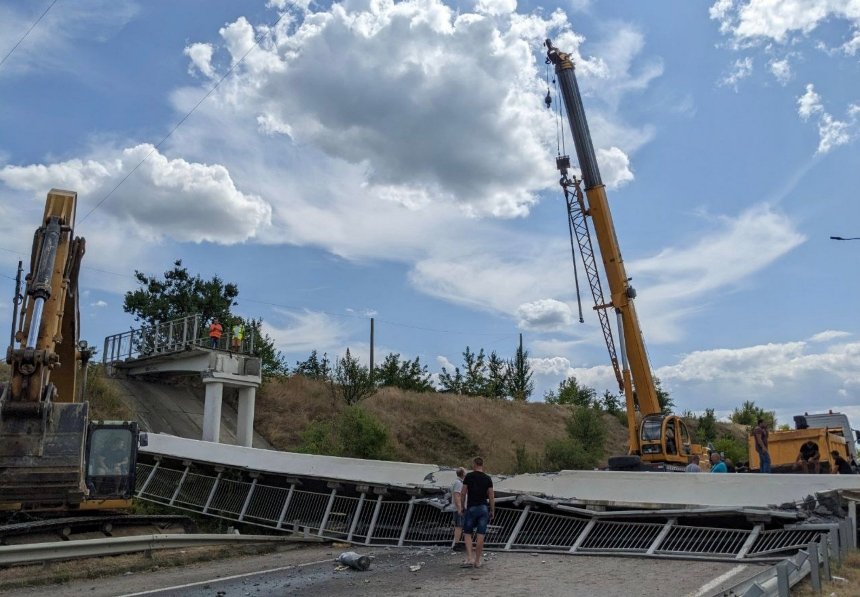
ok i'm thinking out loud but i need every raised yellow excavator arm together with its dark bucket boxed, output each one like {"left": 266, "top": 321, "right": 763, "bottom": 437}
{"left": 0, "top": 189, "right": 88, "bottom": 509}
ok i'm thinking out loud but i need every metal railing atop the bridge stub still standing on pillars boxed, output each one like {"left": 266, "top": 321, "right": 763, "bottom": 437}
{"left": 102, "top": 314, "right": 256, "bottom": 365}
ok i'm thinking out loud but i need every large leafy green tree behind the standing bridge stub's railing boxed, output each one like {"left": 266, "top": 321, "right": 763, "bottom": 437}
{"left": 122, "top": 259, "right": 239, "bottom": 325}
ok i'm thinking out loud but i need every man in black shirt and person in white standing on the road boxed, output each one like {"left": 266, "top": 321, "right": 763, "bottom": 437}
{"left": 451, "top": 456, "right": 496, "bottom": 568}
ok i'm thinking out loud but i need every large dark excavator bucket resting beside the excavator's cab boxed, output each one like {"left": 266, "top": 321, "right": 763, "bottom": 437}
{"left": 0, "top": 401, "right": 89, "bottom": 508}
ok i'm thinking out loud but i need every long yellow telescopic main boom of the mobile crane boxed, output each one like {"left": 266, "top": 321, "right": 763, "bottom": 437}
{"left": 546, "top": 40, "right": 661, "bottom": 415}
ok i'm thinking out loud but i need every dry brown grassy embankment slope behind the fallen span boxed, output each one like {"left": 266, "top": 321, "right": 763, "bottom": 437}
{"left": 254, "top": 376, "right": 627, "bottom": 473}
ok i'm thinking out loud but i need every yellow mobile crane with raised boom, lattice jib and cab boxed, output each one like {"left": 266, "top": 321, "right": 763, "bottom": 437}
{"left": 545, "top": 39, "right": 702, "bottom": 468}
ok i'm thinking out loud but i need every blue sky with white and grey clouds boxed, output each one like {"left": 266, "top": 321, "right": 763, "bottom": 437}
{"left": 0, "top": 0, "right": 860, "bottom": 422}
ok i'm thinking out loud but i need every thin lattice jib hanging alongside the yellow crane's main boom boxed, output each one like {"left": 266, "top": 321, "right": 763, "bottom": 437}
{"left": 561, "top": 177, "right": 624, "bottom": 392}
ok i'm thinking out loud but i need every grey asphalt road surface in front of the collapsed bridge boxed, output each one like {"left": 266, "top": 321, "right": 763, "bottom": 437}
{"left": 4, "top": 546, "right": 761, "bottom": 597}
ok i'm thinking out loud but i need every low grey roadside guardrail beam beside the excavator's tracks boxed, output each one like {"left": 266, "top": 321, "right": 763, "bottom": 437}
{"left": 0, "top": 534, "right": 321, "bottom": 566}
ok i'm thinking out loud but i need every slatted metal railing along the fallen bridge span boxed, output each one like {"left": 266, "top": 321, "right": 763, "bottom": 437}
{"left": 136, "top": 461, "right": 829, "bottom": 561}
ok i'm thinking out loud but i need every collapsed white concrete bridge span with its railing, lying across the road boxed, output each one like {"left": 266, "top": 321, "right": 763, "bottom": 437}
{"left": 136, "top": 434, "right": 860, "bottom": 560}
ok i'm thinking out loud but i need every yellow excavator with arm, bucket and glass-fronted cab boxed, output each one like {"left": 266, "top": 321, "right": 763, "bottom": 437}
{"left": 0, "top": 189, "right": 139, "bottom": 512}
